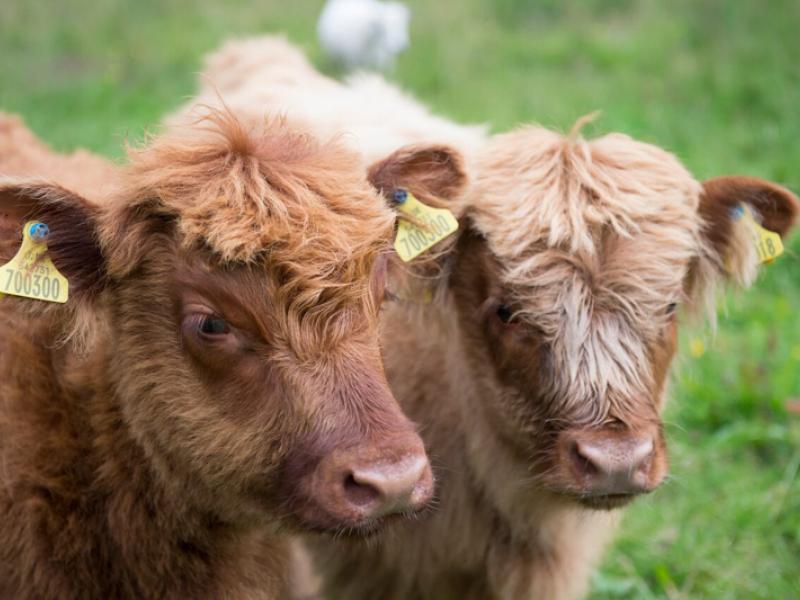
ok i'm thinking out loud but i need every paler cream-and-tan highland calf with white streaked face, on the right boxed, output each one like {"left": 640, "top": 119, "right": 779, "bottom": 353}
{"left": 188, "top": 38, "right": 798, "bottom": 600}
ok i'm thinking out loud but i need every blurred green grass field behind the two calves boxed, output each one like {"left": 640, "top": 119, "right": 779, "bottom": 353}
{"left": 0, "top": 0, "right": 800, "bottom": 600}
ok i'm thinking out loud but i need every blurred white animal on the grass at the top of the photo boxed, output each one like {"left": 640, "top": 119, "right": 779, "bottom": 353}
{"left": 317, "top": 0, "right": 411, "bottom": 70}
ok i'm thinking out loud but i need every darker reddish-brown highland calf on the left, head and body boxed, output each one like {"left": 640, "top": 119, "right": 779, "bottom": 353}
{"left": 0, "top": 113, "right": 450, "bottom": 600}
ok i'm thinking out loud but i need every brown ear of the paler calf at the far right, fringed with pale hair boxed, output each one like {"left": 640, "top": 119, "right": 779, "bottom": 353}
{"left": 699, "top": 176, "right": 800, "bottom": 286}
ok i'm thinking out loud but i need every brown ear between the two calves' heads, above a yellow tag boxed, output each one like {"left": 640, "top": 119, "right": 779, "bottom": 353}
{"left": 367, "top": 145, "right": 467, "bottom": 206}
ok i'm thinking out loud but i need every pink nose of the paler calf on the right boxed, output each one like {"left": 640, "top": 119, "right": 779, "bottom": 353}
{"left": 561, "top": 431, "right": 663, "bottom": 495}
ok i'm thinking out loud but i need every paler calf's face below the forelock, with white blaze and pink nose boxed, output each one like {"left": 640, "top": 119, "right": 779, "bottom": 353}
{"left": 453, "top": 227, "right": 686, "bottom": 507}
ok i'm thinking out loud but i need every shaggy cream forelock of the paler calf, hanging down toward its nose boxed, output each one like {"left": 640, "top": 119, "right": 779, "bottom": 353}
{"left": 466, "top": 127, "right": 708, "bottom": 419}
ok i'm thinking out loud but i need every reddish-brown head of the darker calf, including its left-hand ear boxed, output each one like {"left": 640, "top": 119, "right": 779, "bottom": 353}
{"left": 0, "top": 115, "right": 433, "bottom": 531}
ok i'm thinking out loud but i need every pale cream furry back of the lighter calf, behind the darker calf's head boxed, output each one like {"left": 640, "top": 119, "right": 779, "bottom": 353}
{"left": 167, "top": 36, "right": 487, "bottom": 163}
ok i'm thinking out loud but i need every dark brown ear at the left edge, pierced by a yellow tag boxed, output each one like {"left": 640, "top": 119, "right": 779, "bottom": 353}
{"left": 0, "top": 178, "right": 105, "bottom": 302}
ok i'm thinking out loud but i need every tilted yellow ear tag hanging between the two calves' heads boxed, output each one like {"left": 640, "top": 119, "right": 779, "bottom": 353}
{"left": 394, "top": 190, "right": 458, "bottom": 262}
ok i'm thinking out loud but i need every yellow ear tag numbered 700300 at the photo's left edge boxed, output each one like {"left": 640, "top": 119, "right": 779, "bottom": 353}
{"left": 0, "top": 221, "right": 69, "bottom": 304}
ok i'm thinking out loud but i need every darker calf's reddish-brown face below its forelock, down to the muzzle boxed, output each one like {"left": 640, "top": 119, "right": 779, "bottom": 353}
{"left": 112, "top": 246, "right": 432, "bottom": 532}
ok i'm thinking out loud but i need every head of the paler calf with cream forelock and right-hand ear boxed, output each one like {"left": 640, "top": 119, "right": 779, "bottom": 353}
{"left": 372, "top": 127, "right": 798, "bottom": 508}
